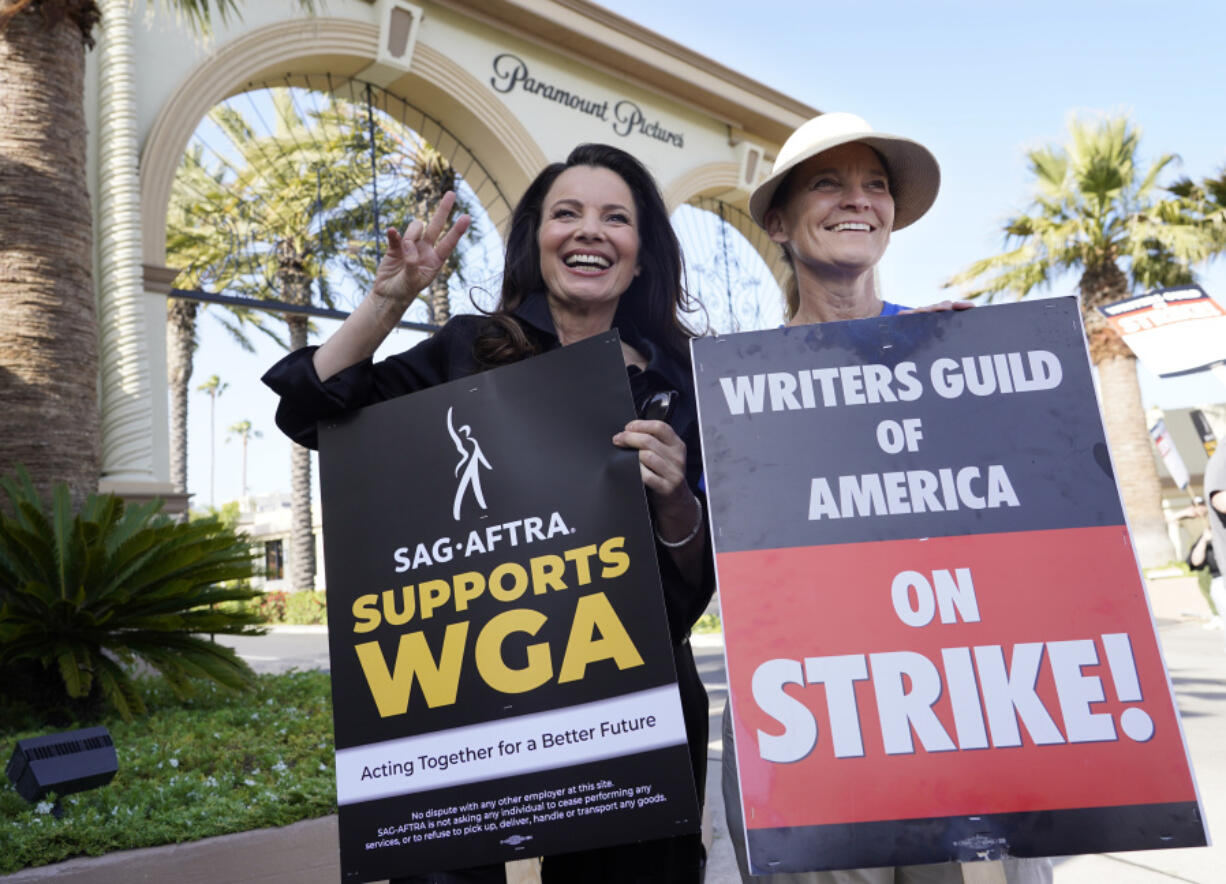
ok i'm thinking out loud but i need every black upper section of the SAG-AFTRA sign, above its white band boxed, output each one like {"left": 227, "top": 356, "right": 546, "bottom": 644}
{"left": 320, "top": 332, "right": 676, "bottom": 749}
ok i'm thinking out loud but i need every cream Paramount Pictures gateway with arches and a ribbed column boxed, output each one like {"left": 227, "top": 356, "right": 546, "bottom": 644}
{"left": 86, "top": 0, "right": 817, "bottom": 499}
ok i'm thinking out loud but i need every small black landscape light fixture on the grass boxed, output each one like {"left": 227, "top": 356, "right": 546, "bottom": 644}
{"left": 5, "top": 727, "right": 119, "bottom": 818}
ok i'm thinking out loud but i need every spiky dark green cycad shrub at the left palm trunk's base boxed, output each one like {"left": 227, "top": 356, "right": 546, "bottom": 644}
{"left": 0, "top": 468, "right": 262, "bottom": 721}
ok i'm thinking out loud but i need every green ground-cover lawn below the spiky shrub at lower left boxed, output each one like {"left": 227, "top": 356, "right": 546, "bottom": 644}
{"left": 0, "top": 671, "right": 336, "bottom": 874}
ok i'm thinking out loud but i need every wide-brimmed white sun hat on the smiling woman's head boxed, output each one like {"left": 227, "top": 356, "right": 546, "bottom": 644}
{"left": 749, "top": 113, "right": 940, "bottom": 231}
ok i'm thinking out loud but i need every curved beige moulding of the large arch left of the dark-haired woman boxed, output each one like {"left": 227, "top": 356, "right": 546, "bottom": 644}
{"left": 141, "top": 18, "right": 546, "bottom": 266}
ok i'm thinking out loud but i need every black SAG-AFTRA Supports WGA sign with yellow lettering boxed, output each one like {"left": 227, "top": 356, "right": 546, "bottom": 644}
{"left": 320, "top": 332, "right": 700, "bottom": 882}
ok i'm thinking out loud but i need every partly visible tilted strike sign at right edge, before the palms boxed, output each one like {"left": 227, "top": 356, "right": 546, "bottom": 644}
{"left": 1098, "top": 286, "right": 1226, "bottom": 378}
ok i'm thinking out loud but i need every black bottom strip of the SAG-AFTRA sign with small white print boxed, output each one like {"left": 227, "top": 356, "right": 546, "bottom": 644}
{"left": 341, "top": 745, "right": 701, "bottom": 882}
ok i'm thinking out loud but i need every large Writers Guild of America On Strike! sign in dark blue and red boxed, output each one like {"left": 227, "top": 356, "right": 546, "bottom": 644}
{"left": 693, "top": 298, "right": 1205, "bottom": 873}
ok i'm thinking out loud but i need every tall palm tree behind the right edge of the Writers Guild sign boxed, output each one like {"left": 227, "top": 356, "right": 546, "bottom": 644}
{"left": 945, "top": 116, "right": 1214, "bottom": 566}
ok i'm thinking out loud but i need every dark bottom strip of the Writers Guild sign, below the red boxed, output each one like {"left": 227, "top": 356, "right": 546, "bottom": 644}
{"left": 749, "top": 801, "right": 1206, "bottom": 874}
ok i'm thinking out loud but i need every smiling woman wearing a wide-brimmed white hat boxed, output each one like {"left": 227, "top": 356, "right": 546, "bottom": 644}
{"left": 723, "top": 113, "right": 1052, "bottom": 884}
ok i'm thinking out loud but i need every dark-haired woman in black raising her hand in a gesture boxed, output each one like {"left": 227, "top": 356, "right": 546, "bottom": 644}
{"left": 264, "top": 145, "right": 714, "bottom": 884}
